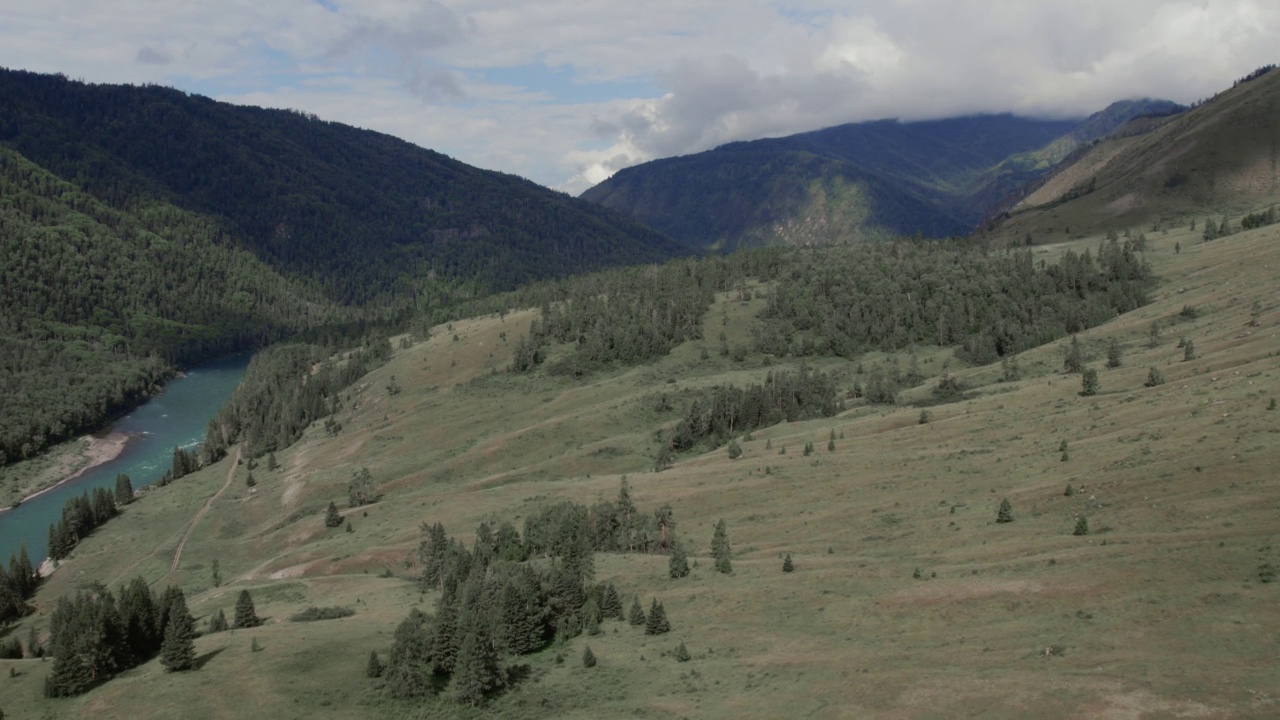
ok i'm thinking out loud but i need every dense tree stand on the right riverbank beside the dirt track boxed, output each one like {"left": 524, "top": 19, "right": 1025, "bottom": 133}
{"left": 201, "top": 334, "right": 392, "bottom": 462}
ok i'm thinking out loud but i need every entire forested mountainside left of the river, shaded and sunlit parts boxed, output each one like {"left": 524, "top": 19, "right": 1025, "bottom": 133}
{"left": 0, "top": 70, "right": 684, "bottom": 465}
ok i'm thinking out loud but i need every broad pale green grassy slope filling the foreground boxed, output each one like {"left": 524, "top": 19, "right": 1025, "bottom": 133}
{"left": 0, "top": 215, "right": 1280, "bottom": 717}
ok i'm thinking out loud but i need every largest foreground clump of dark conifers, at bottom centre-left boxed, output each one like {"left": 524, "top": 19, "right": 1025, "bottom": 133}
{"left": 384, "top": 483, "right": 675, "bottom": 706}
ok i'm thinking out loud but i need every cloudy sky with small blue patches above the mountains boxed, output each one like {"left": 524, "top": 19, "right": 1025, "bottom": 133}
{"left": 0, "top": 0, "right": 1280, "bottom": 195}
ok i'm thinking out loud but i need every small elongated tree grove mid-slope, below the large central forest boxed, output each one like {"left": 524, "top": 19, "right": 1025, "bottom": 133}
{"left": 666, "top": 368, "right": 841, "bottom": 452}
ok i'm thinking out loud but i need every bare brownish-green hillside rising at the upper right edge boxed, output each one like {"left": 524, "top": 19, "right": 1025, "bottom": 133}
{"left": 992, "top": 65, "right": 1280, "bottom": 242}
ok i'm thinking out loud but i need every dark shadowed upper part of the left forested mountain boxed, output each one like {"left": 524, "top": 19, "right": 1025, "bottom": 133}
{"left": 0, "top": 70, "right": 680, "bottom": 302}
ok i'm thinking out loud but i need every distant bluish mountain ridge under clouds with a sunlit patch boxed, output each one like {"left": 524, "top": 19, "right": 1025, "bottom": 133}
{"left": 581, "top": 100, "right": 1181, "bottom": 249}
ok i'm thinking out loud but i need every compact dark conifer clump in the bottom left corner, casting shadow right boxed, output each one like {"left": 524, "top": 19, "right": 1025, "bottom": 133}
{"left": 45, "top": 577, "right": 196, "bottom": 697}
